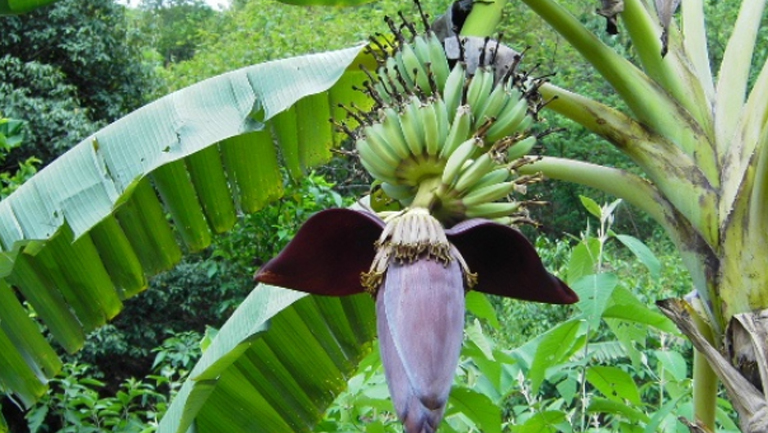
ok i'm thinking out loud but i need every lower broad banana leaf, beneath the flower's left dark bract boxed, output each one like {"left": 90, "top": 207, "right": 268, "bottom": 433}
{"left": 158, "top": 285, "right": 375, "bottom": 433}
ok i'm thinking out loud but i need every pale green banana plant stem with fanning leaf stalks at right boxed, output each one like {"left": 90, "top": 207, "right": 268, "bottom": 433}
{"left": 456, "top": 0, "right": 768, "bottom": 432}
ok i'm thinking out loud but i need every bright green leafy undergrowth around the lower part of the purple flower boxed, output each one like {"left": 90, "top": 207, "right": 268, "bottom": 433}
{"left": 315, "top": 199, "right": 738, "bottom": 433}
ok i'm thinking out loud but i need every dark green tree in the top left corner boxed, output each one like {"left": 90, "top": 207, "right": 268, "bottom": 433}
{"left": 0, "top": 0, "right": 155, "bottom": 163}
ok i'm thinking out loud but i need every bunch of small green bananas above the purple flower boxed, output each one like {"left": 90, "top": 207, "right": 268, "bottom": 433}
{"left": 338, "top": 9, "right": 540, "bottom": 226}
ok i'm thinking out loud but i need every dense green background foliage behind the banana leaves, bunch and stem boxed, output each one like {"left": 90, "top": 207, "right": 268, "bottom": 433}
{"left": 0, "top": 0, "right": 768, "bottom": 432}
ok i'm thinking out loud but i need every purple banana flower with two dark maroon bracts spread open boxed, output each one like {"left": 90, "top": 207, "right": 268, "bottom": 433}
{"left": 255, "top": 208, "right": 578, "bottom": 433}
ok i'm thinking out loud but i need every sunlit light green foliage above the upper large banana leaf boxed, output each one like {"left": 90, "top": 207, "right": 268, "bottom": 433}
{"left": 161, "top": 0, "right": 450, "bottom": 94}
